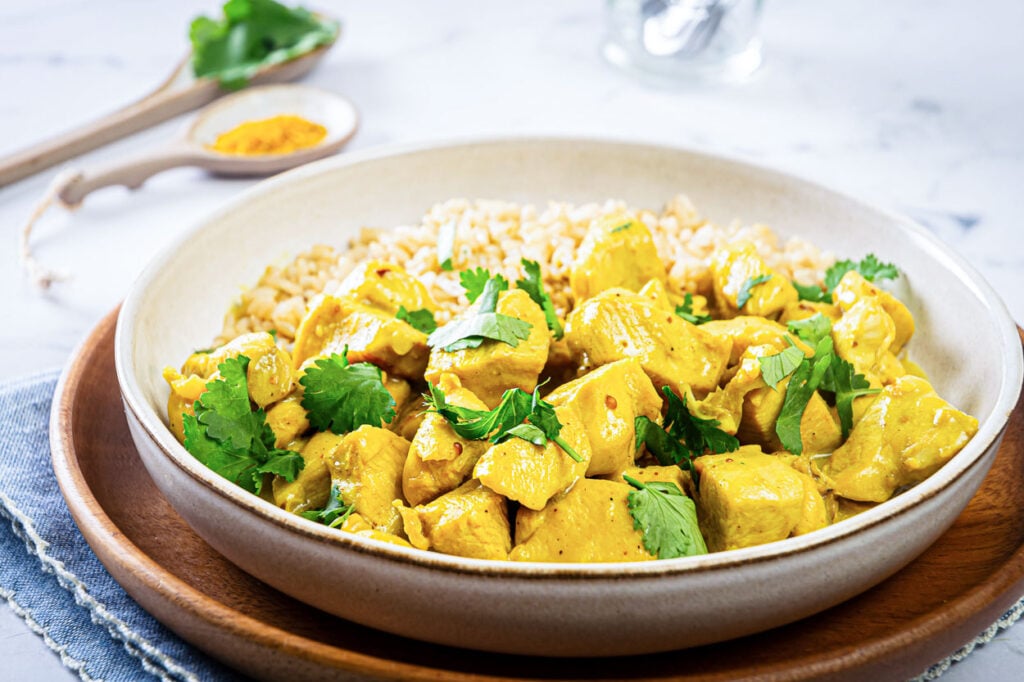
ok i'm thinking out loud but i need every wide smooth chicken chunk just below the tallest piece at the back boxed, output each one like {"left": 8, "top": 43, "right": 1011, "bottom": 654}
{"left": 565, "top": 289, "right": 732, "bottom": 395}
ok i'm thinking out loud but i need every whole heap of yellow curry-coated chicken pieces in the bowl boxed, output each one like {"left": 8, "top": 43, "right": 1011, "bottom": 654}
{"left": 165, "top": 209, "right": 978, "bottom": 562}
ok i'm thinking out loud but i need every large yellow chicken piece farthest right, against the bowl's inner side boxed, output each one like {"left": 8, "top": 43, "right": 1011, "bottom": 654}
{"left": 824, "top": 376, "right": 978, "bottom": 502}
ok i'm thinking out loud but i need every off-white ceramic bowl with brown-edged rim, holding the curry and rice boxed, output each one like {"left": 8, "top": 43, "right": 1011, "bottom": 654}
{"left": 116, "top": 138, "right": 1022, "bottom": 656}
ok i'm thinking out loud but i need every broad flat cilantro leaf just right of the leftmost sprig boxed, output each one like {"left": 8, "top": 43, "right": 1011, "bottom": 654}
{"left": 299, "top": 346, "right": 395, "bottom": 435}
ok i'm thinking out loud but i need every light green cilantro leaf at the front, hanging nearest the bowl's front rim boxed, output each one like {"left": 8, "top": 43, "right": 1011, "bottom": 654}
{"left": 623, "top": 475, "right": 708, "bottom": 559}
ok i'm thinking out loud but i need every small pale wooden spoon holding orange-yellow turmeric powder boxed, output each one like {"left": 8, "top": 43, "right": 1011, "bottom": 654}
{"left": 54, "top": 85, "right": 358, "bottom": 206}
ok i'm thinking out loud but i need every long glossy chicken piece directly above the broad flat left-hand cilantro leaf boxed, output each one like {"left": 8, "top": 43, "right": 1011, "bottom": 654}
{"left": 292, "top": 296, "right": 429, "bottom": 380}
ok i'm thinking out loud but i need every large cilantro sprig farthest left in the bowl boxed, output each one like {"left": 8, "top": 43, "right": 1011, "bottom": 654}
{"left": 182, "top": 355, "right": 305, "bottom": 495}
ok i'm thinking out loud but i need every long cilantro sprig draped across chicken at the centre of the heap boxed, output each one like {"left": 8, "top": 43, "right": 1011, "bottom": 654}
{"left": 424, "top": 384, "right": 583, "bottom": 462}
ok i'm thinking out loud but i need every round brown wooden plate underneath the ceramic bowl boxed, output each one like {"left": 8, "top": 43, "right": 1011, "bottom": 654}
{"left": 51, "top": 311, "right": 1024, "bottom": 680}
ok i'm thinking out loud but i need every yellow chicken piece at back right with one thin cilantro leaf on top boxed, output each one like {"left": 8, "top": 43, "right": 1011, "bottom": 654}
{"left": 711, "top": 242, "right": 800, "bottom": 318}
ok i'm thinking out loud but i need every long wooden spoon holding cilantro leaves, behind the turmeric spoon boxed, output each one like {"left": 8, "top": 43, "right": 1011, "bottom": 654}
{"left": 0, "top": 43, "right": 334, "bottom": 187}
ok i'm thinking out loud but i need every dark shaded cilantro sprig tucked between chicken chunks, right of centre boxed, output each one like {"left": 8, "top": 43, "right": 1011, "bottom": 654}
{"left": 634, "top": 386, "right": 739, "bottom": 470}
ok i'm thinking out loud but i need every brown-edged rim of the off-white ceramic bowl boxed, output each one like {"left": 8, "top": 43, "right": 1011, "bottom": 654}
{"left": 115, "top": 135, "right": 1024, "bottom": 581}
